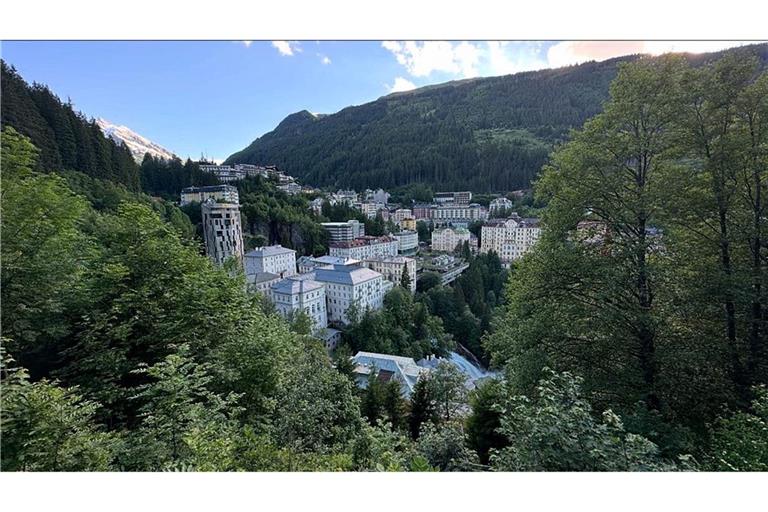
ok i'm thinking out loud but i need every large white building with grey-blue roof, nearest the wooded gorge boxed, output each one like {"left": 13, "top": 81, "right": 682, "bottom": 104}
{"left": 315, "top": 265, "right": 385, "bottom": 323}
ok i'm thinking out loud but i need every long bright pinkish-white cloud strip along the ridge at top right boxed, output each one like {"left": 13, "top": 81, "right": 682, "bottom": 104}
{"left": 547, "top": 41, "right": 749, "bottom": 68}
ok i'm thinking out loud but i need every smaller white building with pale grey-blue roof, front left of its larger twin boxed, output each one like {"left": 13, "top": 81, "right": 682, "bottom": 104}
{"left": 270, "top": 278, "right": 328, "bottom": 331}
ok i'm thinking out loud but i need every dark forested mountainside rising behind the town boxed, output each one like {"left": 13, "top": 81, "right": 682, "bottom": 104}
{"left": 225, "top": 44, "right": 768, "bottom": 192}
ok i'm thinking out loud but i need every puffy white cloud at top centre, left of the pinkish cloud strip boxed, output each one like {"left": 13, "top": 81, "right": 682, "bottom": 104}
{"left": 381, "top": 41, "right": 480, "bottom": 77}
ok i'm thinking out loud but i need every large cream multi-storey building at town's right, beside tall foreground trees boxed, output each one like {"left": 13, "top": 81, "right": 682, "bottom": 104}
{"left": 480, "top": 215, "right": 541, "bottom": 263}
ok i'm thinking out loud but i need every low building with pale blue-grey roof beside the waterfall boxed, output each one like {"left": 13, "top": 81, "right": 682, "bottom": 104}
{"left": 352, "top": 352, "right": 430, "bottom": 398}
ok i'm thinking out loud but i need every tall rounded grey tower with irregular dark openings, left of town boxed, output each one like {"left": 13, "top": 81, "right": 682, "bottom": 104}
{"left": 201, "top": 199, "right": 243, "bottom": 265}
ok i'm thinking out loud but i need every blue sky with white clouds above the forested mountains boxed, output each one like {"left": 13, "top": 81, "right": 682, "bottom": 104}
{"left": 1, "top": 41, "right": 752, "bottom": 160}
